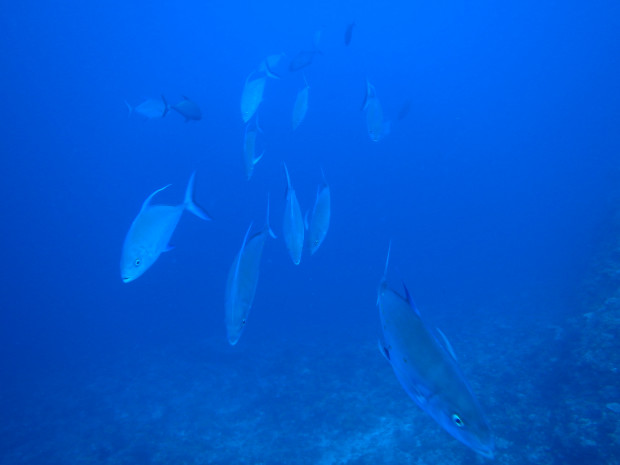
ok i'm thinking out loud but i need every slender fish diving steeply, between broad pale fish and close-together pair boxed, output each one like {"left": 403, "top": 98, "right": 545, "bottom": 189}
{"left": 226, "top": 197, "right": 276, "bottom": 346}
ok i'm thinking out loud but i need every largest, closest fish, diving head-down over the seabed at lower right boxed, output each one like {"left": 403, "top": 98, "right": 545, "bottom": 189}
{"left": 377, "top": 243, "right": 494, "bottom": 458}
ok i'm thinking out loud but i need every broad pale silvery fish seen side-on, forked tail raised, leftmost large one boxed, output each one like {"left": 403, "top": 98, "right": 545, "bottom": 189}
{"left": 121, "top": 172, "right": 211, "bottom": 283}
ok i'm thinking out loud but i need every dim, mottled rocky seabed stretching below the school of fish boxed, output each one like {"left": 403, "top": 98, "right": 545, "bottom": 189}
{"left": 0, "top": 299, "right": 620, "bottom": 465}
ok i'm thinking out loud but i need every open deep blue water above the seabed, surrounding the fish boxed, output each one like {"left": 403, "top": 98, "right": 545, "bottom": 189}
{"left": 0, "top": 1, "right": 620, "bottom": 428}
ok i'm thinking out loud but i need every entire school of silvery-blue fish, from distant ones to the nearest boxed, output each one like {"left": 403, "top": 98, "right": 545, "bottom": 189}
{"left": 120, "top": 22, "right": 494, "bottom": 458}
